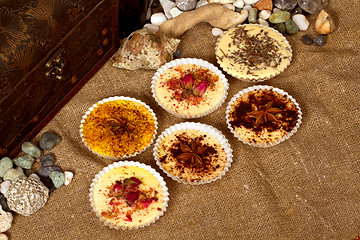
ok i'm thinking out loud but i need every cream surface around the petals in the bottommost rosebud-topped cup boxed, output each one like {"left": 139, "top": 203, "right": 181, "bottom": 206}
{"left": 94, "top": 166, "right": 164, "bottom": 228}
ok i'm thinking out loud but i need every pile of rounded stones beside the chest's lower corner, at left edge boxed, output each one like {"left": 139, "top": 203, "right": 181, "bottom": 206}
{"left": 0, "top": 132, "right": 73, "bottom": 240}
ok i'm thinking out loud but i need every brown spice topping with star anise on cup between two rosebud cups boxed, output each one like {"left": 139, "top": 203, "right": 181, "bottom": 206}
{"left": 159, "top": 132, "right": 227, "bottom": 182}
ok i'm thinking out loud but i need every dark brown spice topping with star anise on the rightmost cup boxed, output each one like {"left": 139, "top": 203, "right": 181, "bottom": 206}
{"left": 230, "top": 90, "right": 298, "bottom": 132}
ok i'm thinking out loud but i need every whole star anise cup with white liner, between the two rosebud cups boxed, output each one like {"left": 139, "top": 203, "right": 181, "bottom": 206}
{"left": 154, "top": 122, "right": 232, "bottom": 185}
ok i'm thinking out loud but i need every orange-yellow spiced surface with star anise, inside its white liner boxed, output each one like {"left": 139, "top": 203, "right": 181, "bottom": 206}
{"left": 82, "top": 100, "right": 155, "bottom": 157}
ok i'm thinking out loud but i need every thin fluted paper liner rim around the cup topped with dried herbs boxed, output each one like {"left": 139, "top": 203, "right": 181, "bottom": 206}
{"left": 215, "top": 24, "right": 292, "bottom": 82}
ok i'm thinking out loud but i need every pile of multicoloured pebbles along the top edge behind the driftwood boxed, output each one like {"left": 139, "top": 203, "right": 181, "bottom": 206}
{"left": 144, "top": 0, "right": 333, "bottom": 46}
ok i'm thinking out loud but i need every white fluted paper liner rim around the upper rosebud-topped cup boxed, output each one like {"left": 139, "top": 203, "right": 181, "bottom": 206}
{"left": 151, "top": 58, "right": 229, "bottom": 119}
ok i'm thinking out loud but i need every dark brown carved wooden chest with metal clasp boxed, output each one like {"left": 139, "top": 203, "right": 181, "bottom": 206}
{"left": 0, "top": 0, "right": 119, "bottom": 157}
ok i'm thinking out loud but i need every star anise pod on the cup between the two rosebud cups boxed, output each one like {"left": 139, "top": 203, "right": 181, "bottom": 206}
{"left": 177, "top": 141, "right": 207, "bottom": 165}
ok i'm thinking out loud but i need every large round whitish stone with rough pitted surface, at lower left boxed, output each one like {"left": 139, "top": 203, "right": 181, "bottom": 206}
{"left": 7, "top": 177, "right": 49, "bottom": 216}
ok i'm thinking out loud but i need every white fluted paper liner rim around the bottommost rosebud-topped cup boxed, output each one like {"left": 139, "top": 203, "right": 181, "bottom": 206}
{"left": 89, "top": 161, "right": 169, "bottom": 230}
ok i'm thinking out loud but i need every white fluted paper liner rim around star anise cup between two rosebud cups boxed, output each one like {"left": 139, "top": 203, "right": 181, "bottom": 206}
{"left": 154, "top": 122, "right": 233, "bottom": 185}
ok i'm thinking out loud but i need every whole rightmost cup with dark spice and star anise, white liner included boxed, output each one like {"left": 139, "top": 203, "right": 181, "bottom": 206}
{"left": 226, "top": 85, "right": 302, "bottom": 147}
